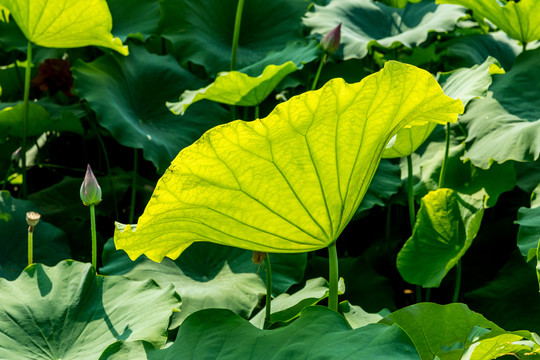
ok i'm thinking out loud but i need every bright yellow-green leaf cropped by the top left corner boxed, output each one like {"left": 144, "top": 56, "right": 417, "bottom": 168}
{"left": 0, "top": 0, "right": 128, "bottom": 55}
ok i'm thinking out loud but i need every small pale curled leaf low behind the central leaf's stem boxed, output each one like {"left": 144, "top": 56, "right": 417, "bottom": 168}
{"left": 249, "top": 278, "right": 345, "bottom": 329}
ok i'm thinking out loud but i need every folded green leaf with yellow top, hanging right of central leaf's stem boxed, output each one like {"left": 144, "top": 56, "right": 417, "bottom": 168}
{"left": 396, "top": 188, "right": 484, "bottom": 287}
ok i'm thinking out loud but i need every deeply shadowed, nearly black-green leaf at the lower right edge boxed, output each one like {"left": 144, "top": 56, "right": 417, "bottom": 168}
{"left": 463, "top": 249, "right": 540, "bottom": 333}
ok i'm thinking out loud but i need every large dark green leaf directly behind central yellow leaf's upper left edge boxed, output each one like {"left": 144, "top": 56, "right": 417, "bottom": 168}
{"left": 73, "top": 45, "right": 230, "bottom": 172}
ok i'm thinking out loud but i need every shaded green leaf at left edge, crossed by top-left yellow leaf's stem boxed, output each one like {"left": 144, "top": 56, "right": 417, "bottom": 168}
{"left": 0, "top": 102, "right": 84, "bottom": 141}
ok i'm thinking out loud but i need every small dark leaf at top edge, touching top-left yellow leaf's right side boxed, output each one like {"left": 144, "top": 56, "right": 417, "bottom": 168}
{"left": 107, "top": 0, "right": 161, "bottom": 41}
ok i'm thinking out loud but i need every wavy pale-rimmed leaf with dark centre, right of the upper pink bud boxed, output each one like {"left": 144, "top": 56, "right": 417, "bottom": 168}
{"left": 304, "top": 0, "right": 466, "bottom": 60}
